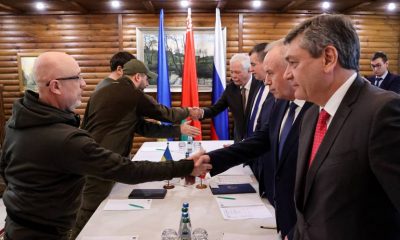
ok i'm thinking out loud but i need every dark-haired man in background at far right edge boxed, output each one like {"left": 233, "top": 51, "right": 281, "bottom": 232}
{"left": 367, "top": 52, "right": 400, "bottom": 93}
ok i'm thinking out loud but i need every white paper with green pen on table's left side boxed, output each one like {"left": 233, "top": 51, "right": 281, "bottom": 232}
{"left": 104, "top": 199, "right": 151, "bottom": 211}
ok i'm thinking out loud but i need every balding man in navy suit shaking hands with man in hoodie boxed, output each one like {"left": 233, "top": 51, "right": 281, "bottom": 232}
{"left": 197, "top": 40, "right": 311, "bottom": 237}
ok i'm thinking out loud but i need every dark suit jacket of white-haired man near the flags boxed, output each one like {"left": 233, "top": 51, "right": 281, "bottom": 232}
{"left": 203, "top": 77, "right": 263, "bottom": 142}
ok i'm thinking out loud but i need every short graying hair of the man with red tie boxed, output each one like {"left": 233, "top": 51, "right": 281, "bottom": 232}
{"left": 285, "top": 14, "right": 360, "bottom": 71}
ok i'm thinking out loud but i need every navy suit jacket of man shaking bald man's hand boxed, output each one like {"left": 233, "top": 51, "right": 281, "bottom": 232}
{"left": 208, "top": 100, "right": 311, "bottom": 238}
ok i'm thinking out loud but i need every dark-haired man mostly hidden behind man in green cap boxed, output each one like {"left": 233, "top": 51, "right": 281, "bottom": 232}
{"left": 95, "top": 52, "right": 136, "bottom": 91}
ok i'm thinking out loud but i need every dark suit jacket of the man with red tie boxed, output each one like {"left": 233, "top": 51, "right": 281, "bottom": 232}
{"left": 295, "top": 77, "right": 400, "bottom": 240}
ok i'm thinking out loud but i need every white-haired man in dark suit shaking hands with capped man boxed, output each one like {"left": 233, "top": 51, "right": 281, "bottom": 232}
{"left": 203, "top": 54, "right": 262, "bottom": 142}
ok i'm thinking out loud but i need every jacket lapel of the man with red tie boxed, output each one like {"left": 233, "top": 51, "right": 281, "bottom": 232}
{"left": 303, "top": 76, "right": 365, "bottom": 205}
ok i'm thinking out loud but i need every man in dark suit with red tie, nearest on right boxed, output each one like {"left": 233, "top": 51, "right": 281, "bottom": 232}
{"left": 285, "top": 15, "right": 400, "bottom": 240}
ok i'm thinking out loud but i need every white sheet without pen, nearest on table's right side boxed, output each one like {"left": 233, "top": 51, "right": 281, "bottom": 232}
{"left": 220, "top": 206, "right": 272, "bottom": 220}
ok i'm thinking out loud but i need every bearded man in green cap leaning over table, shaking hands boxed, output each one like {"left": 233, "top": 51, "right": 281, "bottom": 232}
{"left": 72, "top": 59, "right": 200, "bottom": 237}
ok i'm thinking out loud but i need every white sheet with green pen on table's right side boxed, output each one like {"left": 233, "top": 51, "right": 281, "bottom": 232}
{"left": 215, "top": 194, "right": 264, "bottom": 208}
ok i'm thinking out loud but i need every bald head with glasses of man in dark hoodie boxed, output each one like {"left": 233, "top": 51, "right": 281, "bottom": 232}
{"left": 33, "top": 52, "right": 86, "bottom": 111}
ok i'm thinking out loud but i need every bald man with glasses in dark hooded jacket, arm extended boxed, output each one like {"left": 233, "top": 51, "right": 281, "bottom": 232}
{"left": 0, "top": 52, "right": 211, "bottom": 240}
